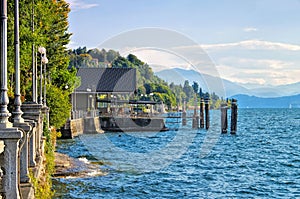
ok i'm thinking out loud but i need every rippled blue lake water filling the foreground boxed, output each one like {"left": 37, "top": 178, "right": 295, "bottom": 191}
{"left": 54, "top": 109, "right": 300, "bottom": 199}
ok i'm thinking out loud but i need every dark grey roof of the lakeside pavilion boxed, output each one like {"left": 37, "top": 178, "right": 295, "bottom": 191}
{"left": 76, "top": 68, "right": 136, "bottom": 93}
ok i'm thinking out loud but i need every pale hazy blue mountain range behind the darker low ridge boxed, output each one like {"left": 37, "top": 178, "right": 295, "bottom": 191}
{"left": 155, "top": 68, "right": 300, "bottom": 97}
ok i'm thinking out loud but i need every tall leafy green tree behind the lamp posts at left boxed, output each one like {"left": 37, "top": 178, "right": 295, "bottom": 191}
{"left": 8, "top": 0, "right": 76, "bottom": 127}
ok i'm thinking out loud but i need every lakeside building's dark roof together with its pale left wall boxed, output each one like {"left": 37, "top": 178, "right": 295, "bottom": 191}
{"left": 72, "top": 68, "right": 137, "bottom": 117}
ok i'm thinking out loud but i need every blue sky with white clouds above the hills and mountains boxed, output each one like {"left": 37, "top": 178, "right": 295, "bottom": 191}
{"left": 67, "top": 0, "right": 300, "bottom": 87}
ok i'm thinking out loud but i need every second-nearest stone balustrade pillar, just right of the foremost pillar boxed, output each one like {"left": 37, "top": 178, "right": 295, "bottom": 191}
{"left": 14, "top": 123, "right": 32, "bottom": 183}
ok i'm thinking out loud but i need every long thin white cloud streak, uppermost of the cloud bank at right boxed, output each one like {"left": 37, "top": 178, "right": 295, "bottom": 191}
{"left": 201, "top": 40, "right": 300, "bottom": 51}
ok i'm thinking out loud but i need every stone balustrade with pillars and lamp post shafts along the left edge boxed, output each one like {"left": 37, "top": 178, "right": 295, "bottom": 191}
{"left": 0, "top": 0, "right": 49, "bottom": 199}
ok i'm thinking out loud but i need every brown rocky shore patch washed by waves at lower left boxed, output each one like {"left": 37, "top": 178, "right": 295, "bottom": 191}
{"left": 53, "top": 152, "right": 105, "bottom": 178}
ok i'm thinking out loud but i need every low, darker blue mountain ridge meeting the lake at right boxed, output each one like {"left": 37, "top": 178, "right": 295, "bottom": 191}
{"left": 232, "top": 95, "right": 300, "bottom": 108}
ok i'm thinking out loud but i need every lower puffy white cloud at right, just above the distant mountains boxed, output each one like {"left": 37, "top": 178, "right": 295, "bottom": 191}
{"left": 217, "top": 58, "right": 300, "bottom": 85}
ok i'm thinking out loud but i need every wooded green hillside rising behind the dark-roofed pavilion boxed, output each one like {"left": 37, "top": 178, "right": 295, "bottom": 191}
{"left": 69, "top": 47, "right": 222, "bottom": 110}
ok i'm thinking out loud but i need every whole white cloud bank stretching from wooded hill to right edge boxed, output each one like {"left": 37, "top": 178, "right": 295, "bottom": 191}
{"left": 109, "top": 40, "right": 300, "bottom": 86}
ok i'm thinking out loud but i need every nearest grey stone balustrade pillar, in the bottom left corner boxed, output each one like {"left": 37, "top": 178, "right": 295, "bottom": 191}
{"left": 0, "top": 128, "right": 23, "bottom": 199}
